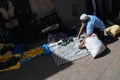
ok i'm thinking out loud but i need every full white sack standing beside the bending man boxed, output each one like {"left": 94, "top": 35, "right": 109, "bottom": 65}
{"left": 85, "top": 33, "right": 105, "bottom": 58}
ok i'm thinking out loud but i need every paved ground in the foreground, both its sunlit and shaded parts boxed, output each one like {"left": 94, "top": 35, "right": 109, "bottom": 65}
{"left": 0, "top": 37, "right": 120, "bottom": 80}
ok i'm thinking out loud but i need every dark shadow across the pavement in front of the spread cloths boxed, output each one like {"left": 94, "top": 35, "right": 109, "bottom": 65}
{"left": 0, "top": 54, "right": 72, "bottom": 80}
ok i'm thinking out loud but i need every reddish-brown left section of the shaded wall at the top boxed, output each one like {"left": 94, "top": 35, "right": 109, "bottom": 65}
{"left": 29, "top": 0, "right": 54, "bottom": 17}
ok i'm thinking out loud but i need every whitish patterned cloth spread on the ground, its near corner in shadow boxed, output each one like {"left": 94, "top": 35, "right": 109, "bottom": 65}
{"left": 49, "top": 37, "right": 89, "bottom": 66}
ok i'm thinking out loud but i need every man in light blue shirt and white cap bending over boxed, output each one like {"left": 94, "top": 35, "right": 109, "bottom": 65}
{"left": 78, "top": 14, "right": 105, "bottom": 48}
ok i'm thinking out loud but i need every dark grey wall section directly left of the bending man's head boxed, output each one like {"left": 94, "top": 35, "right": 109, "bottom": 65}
{"left": 56, "top": 0, "right": 86, "bottom": 28}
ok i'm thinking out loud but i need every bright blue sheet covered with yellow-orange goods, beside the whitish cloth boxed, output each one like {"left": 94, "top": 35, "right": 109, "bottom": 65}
{"left": 20, "top": 44, "right": 51, "bottom": 64}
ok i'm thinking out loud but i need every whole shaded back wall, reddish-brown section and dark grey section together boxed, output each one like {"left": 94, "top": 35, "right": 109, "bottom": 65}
{"left": 29, "top": 0, "right": 86, "bottom": 28}
